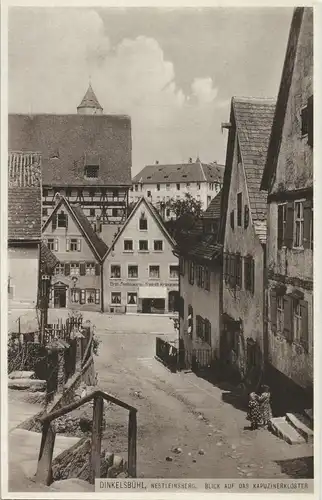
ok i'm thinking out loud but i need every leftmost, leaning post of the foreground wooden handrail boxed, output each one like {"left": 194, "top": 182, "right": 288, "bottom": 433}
{"left": 36, "top": 422, "right": 56, "bottom": 486}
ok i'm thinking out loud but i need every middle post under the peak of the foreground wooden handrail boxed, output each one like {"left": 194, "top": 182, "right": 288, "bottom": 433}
{"left": 90, "top": 396, "right": 104, "bottom": 484}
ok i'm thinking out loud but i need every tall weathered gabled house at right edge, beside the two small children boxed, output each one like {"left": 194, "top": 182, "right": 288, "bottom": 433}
{"left": 261, "top": 8, "right": 313, "bottom": 411}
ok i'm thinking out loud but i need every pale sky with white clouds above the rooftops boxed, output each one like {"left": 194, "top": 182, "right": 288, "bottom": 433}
{"left": 8, "top": 7, "right": 293, "bottom": 175}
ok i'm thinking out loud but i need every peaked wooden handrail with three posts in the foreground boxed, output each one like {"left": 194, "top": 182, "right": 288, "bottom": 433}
{"left": 36, "top": 391, "right": 137, "bottom": 486}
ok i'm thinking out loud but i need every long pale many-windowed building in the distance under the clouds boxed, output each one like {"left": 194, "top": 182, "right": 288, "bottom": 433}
{"left": 129, "top": 158, "right": 224, "bottom": 220}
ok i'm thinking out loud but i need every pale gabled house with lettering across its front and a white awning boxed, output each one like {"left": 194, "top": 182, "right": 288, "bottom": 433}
{"left": 104, "top": 198, "right": 179, "bottom": 313}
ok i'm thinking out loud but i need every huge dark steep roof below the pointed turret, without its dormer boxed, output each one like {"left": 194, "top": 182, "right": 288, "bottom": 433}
{"left": 9, "top": 114, "right": 132, "bottom": 187}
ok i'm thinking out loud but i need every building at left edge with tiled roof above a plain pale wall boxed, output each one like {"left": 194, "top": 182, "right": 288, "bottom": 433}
{"left": 8, "top": 151, "right": 41, "bottom": 333}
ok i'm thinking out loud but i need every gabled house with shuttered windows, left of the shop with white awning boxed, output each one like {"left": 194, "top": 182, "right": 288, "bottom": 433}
{"left": 42, "top": 197, "right": 108, "bottom": 311}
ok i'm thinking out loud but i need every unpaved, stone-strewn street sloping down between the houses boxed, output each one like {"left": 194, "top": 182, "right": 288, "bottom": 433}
{"left": 87, "top": 317, "right": 313, "bottom": 478}
